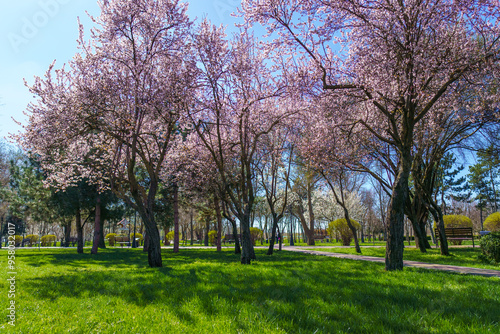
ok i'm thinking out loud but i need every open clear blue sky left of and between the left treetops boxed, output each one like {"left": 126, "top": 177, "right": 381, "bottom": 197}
{"left": 0, "top": 0, "right": 240, "bottom": 142}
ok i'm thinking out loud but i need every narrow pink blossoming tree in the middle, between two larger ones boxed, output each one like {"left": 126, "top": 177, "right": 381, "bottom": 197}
{"left": 191, "top": 21, "right": 286, "bottom": 264}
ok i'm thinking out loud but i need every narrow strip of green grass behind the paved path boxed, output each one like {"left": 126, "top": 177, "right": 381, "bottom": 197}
{"left": 311, "top": 246, "right": 500, "bottom": 270}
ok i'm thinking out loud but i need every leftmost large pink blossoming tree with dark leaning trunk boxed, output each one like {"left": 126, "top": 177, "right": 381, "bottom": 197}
{"left": 18, "top": 0, "right": 196, "bottom": 267}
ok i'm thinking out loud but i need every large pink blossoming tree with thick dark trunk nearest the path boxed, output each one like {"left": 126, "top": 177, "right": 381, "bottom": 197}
{"left": 242, "top": 0, "right": 500, "bottom": 270}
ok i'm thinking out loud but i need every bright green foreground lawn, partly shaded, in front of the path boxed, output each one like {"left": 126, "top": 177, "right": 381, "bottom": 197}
{"left": 0, "top": 249, "right": 500, "bottom": 333}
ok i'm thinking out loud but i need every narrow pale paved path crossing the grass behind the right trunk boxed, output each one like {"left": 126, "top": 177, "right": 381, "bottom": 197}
{"left": 283, "top": 246, "right": 500, "bottom": 278}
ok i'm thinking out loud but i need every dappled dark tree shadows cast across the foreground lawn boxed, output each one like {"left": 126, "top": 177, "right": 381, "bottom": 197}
{"left": 23, "top": 250, "right": 500, "bottom": 333}
